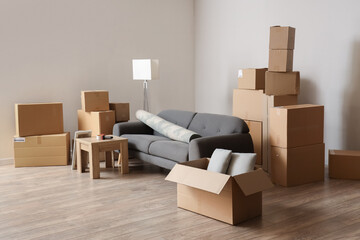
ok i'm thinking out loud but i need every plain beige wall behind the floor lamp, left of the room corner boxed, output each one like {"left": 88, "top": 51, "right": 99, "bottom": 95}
{"left": 0, "top": 0, "right": 194, "bottom": 158}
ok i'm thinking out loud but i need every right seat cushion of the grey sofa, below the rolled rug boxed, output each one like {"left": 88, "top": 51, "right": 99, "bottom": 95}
{"left": 149, "top": 140, "right": 189, "bottom": 162}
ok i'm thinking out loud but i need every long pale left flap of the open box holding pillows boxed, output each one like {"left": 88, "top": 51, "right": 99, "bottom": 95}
{"left": 165, "top": 164, "right": 231, "bottom": 194}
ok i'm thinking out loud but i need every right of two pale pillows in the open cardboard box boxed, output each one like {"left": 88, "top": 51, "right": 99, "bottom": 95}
{"left": 227, "top": 153, "right": 256, "bottom": 176}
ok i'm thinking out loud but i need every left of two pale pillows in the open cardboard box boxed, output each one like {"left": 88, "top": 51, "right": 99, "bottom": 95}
{"left": 207, "top": 148, "right": 231, "bottom": 173}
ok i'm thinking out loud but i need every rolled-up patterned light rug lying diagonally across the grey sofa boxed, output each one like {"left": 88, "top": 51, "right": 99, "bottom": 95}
{"left": 136, "top": 110, "right": 200, "bottom": 143}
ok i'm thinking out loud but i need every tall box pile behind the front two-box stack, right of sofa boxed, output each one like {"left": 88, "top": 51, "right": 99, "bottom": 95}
{"left": 233, "top": 27, "right": 300, "bottom": 171}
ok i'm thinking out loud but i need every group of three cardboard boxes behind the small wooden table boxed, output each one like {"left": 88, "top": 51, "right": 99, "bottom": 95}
{"left": 78, "top": 90, "right": 130, "bottom": 136}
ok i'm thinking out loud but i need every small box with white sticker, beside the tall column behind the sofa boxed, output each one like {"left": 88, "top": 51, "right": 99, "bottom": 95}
{"left": 238, "top": 68, "right": 267, "bottom": 90}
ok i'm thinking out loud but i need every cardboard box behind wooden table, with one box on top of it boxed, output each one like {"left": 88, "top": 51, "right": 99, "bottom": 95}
{"left": 78, "top": 110, "right": 115, "bottom": 136}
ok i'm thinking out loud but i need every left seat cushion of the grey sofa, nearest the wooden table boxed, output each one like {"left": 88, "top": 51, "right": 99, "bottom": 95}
{"left": 121, "top": 134, "right": 169, "bottom": 153}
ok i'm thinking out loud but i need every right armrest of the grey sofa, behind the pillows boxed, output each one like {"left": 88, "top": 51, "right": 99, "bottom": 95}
{"left": 189, "top": 133, "right": 254, "bottom": 161}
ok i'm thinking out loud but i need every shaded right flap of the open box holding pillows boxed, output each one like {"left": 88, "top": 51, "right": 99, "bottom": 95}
{"left": 234, "top": 169, "right": 274, "bottom": 196}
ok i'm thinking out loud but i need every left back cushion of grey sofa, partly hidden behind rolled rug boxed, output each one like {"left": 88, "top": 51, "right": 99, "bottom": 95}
{"left": 154, "top": 110, "right": 196, "bottom": 136}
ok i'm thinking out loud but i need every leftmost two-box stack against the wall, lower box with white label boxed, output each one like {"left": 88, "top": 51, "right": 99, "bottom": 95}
{"left": 14, "top": 103, "right": 70, "bottom": 167}
